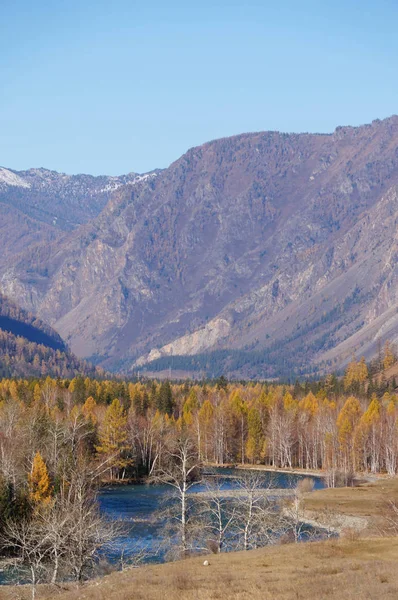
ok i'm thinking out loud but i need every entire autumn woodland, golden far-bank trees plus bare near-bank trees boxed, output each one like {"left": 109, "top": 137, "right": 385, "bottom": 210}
{"left": 0, "top": 343, "right": 398, "bottom": 584}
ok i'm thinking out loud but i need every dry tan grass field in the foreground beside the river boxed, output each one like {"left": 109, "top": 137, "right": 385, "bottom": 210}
{"left": 0, "top": 479, "right": 398, "bottom": 600}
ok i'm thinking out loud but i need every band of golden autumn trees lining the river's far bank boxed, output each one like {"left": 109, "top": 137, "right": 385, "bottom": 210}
{"left": 0, "top": 360, "right": 398, "bottom": 496}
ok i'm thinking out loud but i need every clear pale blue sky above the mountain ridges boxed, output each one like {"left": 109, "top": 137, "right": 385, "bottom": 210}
{"left": 0, "top": 0, "right": 398, "bottom": 175}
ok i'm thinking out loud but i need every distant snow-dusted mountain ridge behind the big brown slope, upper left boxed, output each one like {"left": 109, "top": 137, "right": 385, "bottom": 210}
{"left": 0, "top": 167, "right": 156, "bottom": 264}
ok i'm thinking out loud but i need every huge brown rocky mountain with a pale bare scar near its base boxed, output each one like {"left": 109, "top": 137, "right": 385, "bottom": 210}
{"left": 0, "top": 116, "right": 398, "bottom": 377}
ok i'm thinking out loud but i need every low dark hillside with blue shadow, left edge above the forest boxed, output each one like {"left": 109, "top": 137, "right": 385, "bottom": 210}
{"left": 0, "top": 294, "right": 97, "bottom": 377}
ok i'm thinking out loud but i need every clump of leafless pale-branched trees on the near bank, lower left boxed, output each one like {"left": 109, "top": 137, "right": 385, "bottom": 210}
{"left": 1, "top": 464, "right": 119, "bottom": 598}
